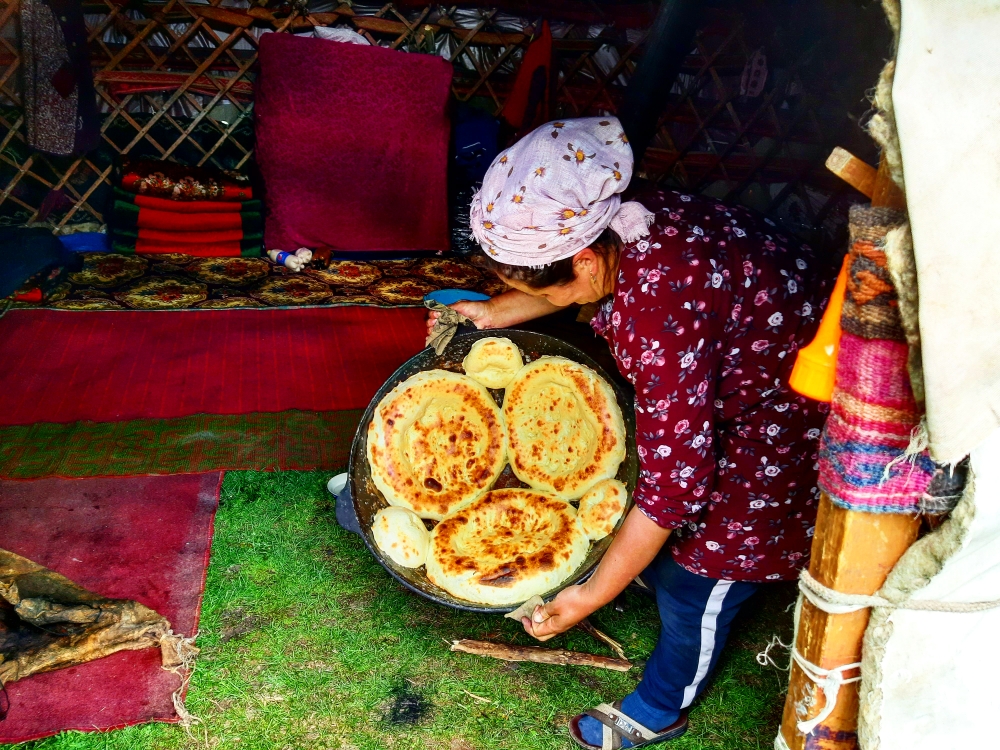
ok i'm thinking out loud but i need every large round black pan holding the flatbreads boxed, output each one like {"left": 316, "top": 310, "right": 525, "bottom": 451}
{"left": 337, "top": 330, "right": 639, "bottom": 612}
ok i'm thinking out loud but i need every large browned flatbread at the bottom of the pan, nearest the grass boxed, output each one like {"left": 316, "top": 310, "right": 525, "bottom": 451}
{"left": 427, "top": 489, "right": 590, "bottom": 606}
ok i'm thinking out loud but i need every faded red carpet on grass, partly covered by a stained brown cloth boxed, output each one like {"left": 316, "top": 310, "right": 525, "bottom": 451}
{"left": 0, "top": 472, "right": 222, "bottom": 743}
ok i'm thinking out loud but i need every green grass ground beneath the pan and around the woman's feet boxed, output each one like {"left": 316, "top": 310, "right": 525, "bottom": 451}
{"left": 23, "top": 472, "right": 793, "bottom": 750}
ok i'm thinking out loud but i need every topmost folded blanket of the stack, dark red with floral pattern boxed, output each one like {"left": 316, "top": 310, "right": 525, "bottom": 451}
{"left": 122, "top": 159, "right": 253, "bottom": 201}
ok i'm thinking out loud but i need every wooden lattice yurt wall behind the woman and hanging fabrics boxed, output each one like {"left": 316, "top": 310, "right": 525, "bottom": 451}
{"left": 0, "top": 0, "right": 887, "bottom": 253}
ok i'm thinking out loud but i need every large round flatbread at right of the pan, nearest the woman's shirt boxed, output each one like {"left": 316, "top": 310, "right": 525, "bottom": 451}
{"left": 503, "top": 357, "right": 625, "bottom": 500}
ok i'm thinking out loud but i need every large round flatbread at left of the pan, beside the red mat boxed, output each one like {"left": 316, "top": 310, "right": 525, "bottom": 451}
{"left": 368, "top": 370, "right": 507, "bottom": 520}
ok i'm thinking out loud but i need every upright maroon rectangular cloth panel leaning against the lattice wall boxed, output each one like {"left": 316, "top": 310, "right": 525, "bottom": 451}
{"left": 254, "top": 34, "right": 451, "bottom": 251}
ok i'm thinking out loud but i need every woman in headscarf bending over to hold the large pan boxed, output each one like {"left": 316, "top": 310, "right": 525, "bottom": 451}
{"left": 434, "top": 117, "right": 826, "bottom": 748}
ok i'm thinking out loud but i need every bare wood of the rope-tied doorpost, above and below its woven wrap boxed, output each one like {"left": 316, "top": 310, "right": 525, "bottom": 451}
{"left": 780, "top": 148, "right": 920, "bottom": 750}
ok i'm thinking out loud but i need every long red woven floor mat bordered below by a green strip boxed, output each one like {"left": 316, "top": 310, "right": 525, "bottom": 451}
{"left": 0, "top": 307, "right": 426, "bottom": 425}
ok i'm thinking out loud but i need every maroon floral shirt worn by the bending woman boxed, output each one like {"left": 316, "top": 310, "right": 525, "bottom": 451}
{"left": 592, "top": 191, "right": 832, "bottom": 581}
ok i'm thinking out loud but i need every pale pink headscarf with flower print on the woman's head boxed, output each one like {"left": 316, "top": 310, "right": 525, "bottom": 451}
{"left": 470, "top": 117, "right": 653, "bottom": 267}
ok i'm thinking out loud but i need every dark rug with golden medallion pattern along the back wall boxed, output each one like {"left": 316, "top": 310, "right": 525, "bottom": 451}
{"left": 15, "top": 253, "right": 505, "bottom": 310}
